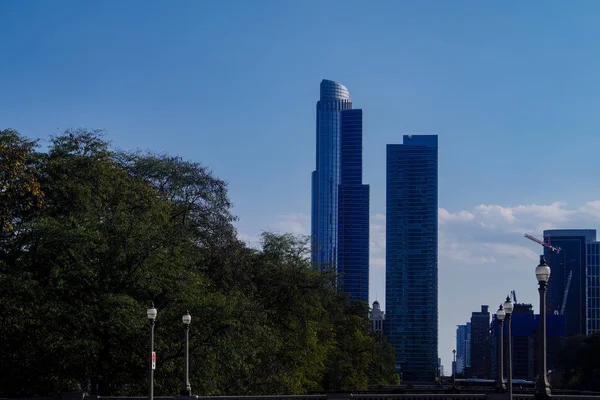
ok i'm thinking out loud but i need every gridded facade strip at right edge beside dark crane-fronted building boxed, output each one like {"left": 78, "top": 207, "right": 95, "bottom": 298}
{"left": 585, "top": 242, "right": 600, "bottom": 335}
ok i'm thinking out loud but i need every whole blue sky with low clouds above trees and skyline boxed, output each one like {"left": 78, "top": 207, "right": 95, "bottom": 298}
{"left": 0, "top": 0, "right": 600, "bottom": 374}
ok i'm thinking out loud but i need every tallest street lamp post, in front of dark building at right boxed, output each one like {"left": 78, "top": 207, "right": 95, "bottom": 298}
{"left": 535, "top": 256, "right": 550, "bottom": 400}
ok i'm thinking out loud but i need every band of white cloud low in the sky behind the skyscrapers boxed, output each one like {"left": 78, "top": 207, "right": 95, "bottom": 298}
{"left": 243, "top": 200, "right": 600, "bottom": 270}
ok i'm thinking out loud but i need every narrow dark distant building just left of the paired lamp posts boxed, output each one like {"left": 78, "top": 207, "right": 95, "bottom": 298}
{"left": 470, "top": 305, "right": 491, "bottom": 379}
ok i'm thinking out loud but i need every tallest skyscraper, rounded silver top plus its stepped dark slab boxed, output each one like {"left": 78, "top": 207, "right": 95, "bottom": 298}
{"left": 311, "top": 79, "right": 369, "bottom": 302}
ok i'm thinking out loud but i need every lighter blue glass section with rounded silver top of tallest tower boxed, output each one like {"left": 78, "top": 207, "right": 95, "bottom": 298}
{"left": 311, "top": 79, "right": 352, "bottom": 269}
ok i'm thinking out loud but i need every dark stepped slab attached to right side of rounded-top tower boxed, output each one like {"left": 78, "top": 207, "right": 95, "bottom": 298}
{"left": 337, "top": 110, "right": 369, "bottom": 303}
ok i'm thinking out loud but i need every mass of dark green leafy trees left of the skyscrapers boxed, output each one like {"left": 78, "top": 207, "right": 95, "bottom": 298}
{"left": 0, "top": 130, "right": 398, "bottom": 397}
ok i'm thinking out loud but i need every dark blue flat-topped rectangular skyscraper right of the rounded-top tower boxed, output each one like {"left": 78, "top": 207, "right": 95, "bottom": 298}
{"left": 384, "top": 135, "right": 438, "bottom": 381}
